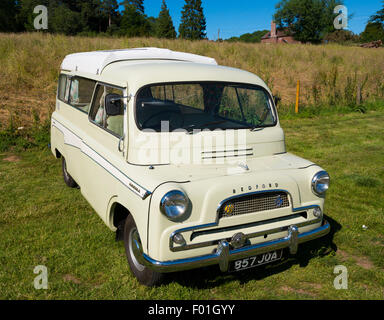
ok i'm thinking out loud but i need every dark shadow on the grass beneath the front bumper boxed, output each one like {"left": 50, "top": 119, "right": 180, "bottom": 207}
{"left": 163, "top": 217, "right": 342, "bottom": 289}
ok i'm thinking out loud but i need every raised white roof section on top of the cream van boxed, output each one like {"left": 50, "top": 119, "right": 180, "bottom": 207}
{"left": 61, "top": 48, "right": 217, "bottom": 75}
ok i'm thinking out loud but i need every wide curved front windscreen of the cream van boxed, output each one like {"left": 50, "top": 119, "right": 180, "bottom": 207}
{"left": 136, "top": 82, "right": 276, "bottom": 131}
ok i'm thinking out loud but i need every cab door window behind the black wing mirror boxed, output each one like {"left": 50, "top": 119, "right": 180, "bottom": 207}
{"left": 89, "top": 84, "right": 124, "bottom": 137}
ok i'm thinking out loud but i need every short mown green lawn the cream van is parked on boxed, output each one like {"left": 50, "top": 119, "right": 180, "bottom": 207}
{"left": 0, "top": 112, "right": 384, "bottom": 300}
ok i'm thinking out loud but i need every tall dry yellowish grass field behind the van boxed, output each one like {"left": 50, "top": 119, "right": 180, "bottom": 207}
{"left": 0, "top": 33, "right": 384, "bottom": 126}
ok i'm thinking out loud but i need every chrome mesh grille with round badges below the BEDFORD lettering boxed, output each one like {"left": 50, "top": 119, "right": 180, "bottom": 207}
{"left": 219, "top": 192, "right": 289, "bottom": 218}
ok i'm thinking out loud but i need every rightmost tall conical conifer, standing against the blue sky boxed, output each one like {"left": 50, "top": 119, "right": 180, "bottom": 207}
{"left": 179, "top": 0, "right": 207, "bottom": 40}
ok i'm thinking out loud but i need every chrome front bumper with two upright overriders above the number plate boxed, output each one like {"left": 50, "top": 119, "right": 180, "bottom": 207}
{"left": 133, "top": 220, "right": 330, "bottom": 273}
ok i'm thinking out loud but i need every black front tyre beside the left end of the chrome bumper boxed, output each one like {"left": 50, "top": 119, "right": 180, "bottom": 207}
{"left": 124, "top": 215, "right": 164, "bottom": 287}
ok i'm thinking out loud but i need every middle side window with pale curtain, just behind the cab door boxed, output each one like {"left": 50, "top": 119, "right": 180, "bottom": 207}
{"left": 68, "top": 77, "right": 96, "bottom": 113}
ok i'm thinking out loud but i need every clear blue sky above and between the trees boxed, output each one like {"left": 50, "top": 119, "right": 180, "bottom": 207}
{"left": 136, "top": 0, "right": 382, "bottom": 40}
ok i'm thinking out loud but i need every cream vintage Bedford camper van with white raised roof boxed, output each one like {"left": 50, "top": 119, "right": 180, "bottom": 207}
{"left": 51, "top": 48, "right": 330, "bottom": 285}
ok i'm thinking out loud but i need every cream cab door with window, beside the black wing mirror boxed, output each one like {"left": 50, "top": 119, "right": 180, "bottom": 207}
{"left": 82, "top": 83, "right": 127, "bottom": 218}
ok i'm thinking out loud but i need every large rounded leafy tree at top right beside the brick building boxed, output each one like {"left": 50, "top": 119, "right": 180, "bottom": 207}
{"left": 274, "top": 0, "right": 343, "bottom": 43}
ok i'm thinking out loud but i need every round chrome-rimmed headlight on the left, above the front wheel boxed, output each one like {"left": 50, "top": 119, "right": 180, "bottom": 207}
{"left": 160, "top": 190, "right": 190, "bottom": 221}
